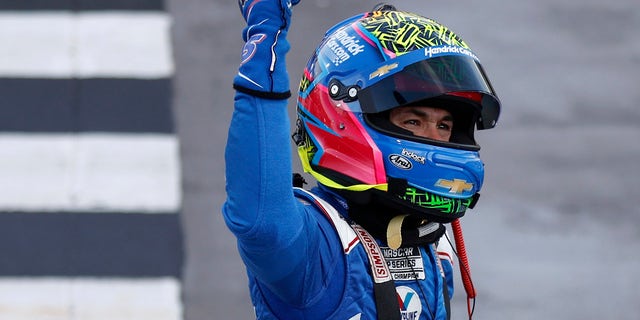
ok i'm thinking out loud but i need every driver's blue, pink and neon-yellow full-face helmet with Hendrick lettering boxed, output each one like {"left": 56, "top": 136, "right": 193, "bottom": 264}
{"left": 293, "top": 7, "right": 500, "bottom": 222}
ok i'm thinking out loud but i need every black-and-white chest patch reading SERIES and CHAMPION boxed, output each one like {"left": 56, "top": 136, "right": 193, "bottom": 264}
{"left": 380, "top": 247, "right": 425, "bottom": 281}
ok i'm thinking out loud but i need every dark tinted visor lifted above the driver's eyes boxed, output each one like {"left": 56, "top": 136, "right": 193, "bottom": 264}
{"left": 358, "top": 55, "right": 499, "bottom": 128}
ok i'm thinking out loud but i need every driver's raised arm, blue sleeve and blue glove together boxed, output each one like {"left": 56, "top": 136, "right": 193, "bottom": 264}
{"left": 222, "top": 0, "right": 341, "bottom": 305}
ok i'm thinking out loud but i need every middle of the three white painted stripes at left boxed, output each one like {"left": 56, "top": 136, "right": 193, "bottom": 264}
{"left": 0, "top": 133, "right": 181, "bottom": 213}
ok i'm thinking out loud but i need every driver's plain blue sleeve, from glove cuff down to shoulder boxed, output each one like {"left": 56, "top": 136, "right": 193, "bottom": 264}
{"left": 222, "top": 93, "right": 343, "bottom": 306}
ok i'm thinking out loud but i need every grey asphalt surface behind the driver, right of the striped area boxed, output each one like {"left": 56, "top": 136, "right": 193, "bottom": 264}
{"left": 168, "top": 0, "right": 640, "bottom": 320}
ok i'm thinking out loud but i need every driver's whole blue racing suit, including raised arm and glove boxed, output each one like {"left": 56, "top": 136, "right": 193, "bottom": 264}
{"left": 222, "top": 0, "right": 453, "bottom": 320}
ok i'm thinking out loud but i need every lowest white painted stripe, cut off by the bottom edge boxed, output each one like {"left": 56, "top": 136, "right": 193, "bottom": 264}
{"left": 0, "top": 278, "right": 182, "bottom": 320}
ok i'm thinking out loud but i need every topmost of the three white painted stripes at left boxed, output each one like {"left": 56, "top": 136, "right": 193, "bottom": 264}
{"left": 0, "top": 11, "right": 174, "bottom": 78}
